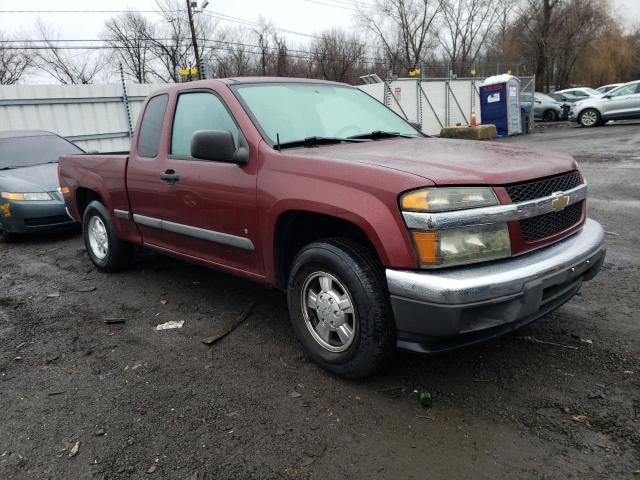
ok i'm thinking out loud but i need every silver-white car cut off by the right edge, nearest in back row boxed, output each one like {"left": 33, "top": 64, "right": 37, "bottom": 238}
{"left": 569, "top": 80, "right": 640, "bottom": 127}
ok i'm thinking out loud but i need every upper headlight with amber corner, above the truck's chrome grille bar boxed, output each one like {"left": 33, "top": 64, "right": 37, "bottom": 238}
{"left": 400, "top": 187, "right": 498, "bottom": 212}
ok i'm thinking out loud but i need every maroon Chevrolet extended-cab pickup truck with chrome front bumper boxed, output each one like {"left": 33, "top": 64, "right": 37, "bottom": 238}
{"left": 59, "top": 78, "right": 605, "bottom": 378}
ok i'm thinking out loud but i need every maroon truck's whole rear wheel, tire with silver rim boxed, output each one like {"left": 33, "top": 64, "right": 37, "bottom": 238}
{"left": 82, "top": 200, "right": 132, "bottom": 272}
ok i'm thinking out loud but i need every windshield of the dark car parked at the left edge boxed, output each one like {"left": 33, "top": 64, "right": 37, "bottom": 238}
{"left": 0, "top": 135, "right": 84, "bottom": 170}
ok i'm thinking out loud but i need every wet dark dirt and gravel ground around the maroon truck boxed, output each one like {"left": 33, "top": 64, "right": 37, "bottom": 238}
{"left": 0, "top": 124, "right": 640, "bottom": 480}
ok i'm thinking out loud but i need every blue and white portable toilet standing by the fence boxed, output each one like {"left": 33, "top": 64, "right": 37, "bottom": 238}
{"left": 480, "top": 75, "right": 522, "bottom": 137}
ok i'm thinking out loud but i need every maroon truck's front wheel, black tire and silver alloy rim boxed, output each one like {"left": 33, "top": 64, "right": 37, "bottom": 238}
{"left": 288, "top": 239, "right": 395, "bottom": 378}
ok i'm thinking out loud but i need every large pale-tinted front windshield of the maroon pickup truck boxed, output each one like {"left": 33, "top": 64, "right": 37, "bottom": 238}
{"left": 232, "top": 83, "right": 420, "bottom": 145}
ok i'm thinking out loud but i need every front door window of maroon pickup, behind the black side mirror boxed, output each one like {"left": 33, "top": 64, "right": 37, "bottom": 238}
{"left": 171, "top": 92, "right": 238, "bottom": 156}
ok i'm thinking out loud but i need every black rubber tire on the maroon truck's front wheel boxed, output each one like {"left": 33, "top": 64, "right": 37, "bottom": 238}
{"left": 287, "top": 239, "right": 396, "bottom": 379}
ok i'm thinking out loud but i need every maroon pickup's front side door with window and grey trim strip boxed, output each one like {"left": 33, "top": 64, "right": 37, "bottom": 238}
{"left": 162, "top": 90, "right": 263, "bottom": 275}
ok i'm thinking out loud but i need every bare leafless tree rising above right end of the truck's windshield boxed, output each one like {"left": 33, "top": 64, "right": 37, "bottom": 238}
{"left": 358, "top": 0, "right": 443, "bottom": 72}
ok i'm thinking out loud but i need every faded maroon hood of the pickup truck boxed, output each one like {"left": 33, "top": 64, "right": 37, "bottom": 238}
{"left": 292, "top": 138, "right": 577, "bottom": 185}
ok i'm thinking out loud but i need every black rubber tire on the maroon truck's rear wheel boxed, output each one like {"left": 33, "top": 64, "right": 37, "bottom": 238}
{"left": 82, "top": 200, "right": 133, "bottom": 272}
